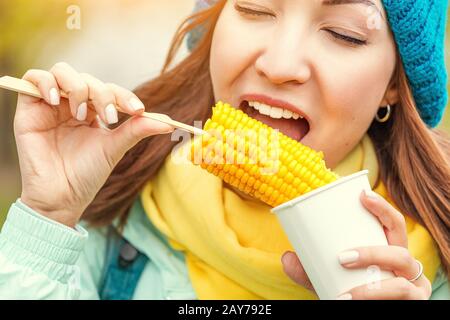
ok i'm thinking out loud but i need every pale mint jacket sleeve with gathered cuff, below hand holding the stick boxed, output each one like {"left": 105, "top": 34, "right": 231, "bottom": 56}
{"left": 0, "top": 199, "right": 98, "bottom": 299}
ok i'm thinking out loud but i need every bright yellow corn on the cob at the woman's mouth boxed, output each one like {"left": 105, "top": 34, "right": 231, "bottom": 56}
{"left": 190, "top": 102, "right": 338, "bottom": 207}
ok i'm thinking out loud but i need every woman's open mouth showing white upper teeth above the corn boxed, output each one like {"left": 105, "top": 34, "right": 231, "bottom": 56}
{"left": 239, "top": 100, "right": 310, "bottom": 141}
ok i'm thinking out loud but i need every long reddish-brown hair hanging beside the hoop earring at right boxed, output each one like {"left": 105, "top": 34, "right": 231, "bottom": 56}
{"left": 369, "top": 60, "right": 450, "bottom": 274}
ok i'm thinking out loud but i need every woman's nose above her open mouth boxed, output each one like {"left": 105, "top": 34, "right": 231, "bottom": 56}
{"left": 255, "top": 29, "right": 311, "bottom": 85}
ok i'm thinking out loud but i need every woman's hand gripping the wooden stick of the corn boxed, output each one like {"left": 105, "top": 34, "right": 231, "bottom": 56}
{"left": 14, "top": 63, "right": 173, "bottom": 227}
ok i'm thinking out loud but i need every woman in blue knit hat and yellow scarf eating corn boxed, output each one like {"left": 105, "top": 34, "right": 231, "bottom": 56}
{"left": 0, "top": 0, "right": 450, "bottom": 299}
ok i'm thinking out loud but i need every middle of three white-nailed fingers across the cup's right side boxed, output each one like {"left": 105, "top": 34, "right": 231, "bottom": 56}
{"left": 338, "top": 246, "right": 420, "bottom": 279}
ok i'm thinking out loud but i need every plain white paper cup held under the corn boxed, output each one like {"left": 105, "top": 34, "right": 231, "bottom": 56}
{"left": 272, "top": 170, "right": 394, "bottom": 300}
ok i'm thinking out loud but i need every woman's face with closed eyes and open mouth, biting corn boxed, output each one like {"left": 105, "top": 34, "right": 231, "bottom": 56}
{"left": 210, "top": 0, "right": 396, "bottom": 168}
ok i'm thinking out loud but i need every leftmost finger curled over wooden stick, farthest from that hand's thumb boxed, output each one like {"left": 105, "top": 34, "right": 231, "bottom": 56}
{"left": 21, "top": 69, "right": 61, "bottom": 106}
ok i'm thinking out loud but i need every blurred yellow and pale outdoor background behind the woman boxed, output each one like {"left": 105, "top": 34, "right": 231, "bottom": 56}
{"left": 0, "top": 0, "right": 450, "bottom": 226}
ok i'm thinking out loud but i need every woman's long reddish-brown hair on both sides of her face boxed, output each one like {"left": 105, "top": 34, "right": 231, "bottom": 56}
{"left": 83, "top": 0, "right": 450, "bottom": 273}
